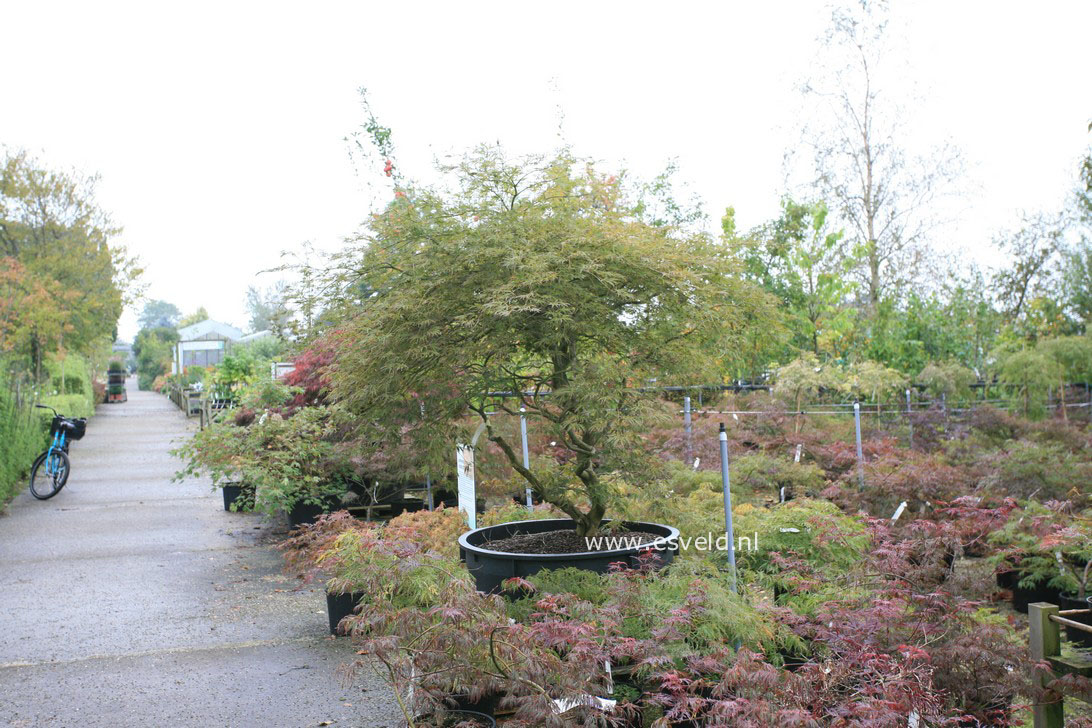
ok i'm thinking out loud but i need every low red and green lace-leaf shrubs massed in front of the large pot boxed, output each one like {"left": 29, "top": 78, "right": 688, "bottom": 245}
{"left": 273, "top": 493, "right": 1048, "bottom": 726}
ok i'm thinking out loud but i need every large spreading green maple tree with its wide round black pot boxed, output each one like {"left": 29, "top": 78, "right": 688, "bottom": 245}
{"left": 330, "top": 148, "right": 771, "bottom": 589}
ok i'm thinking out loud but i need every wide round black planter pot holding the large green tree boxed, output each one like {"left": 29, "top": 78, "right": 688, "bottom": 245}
{"left": 459, "top": 518, "right": 679, "bottom": 594}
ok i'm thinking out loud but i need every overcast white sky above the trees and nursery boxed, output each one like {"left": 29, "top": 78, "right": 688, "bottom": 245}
{"left": 0, "top": 0, "right": 1092, "bottom": 338}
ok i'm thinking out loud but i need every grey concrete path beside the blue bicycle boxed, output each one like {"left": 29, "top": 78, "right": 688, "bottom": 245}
{"left": 0, "top": 380, "right": 401, "bottom": 728}
